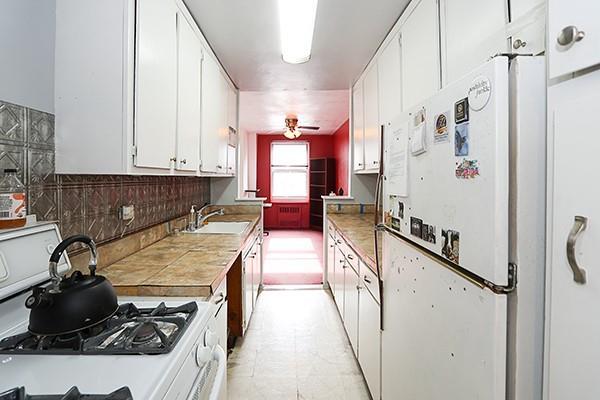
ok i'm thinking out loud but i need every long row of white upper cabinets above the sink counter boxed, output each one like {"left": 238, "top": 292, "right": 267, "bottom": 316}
{"left": 55, "top": 0, "right": 237, "bottom": 175}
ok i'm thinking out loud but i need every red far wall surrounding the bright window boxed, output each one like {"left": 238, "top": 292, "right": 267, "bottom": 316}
{"left": 256, "top": 135, "right": 336, "bottom": 229}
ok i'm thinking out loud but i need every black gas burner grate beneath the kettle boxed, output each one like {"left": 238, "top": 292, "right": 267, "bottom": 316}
{"left": 0, "top": 302, "right": 198, "bottom": 354}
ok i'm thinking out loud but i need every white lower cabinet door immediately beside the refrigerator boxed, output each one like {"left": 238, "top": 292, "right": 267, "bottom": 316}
{"left": 358, "top": 282, "right": 381, "bottom": 399}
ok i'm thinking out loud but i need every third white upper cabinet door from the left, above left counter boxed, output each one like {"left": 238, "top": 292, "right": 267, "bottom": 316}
{"left": 200, "top": 54, "right": 223, "bottom": 173}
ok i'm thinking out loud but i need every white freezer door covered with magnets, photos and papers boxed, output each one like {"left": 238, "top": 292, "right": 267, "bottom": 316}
{"left": 384, "top": 57, "right": 509, "bottom": 285}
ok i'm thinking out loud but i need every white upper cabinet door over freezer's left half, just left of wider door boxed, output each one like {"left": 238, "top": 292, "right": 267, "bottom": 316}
{"left": 400, "top": 0, "right": 440, "bottom": 110}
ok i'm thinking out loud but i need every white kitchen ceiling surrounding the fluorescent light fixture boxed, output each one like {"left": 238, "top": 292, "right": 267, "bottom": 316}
{"left": 184, "top": 0, "right": 409, "bottom": 91}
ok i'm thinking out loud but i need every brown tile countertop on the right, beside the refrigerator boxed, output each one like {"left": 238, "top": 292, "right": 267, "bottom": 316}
{"left": 327, "top": 213, "right": 381, "bottom": 273}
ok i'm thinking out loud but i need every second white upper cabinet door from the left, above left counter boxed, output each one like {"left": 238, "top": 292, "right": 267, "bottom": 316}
{"left": 175, "top": 14, "right": 202, "bottom": 171}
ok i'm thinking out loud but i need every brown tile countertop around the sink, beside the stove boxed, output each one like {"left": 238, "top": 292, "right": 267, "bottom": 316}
{"left": 101, "top": 214, "right": 260, "bottom": 297}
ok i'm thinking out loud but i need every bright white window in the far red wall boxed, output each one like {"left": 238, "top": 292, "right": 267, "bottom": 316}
{"left": 271, "top": 142, "right": 308, "bottom": 201}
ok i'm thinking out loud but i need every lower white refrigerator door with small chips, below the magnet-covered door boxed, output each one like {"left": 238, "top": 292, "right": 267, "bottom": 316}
{"left": 381, "top": 234, "right": 507, "bottom": 400}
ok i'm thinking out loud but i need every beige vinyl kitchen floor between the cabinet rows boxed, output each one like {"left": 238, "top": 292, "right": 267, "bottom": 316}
{"left": 227, "top": 289, "right": 370, "bottom": 400}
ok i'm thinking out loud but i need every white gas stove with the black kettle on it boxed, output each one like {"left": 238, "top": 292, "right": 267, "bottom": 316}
{"left": 0, "top": 224, "right": 226, "bottom": 400}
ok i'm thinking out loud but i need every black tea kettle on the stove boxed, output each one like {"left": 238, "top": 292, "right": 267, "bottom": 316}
{"left": 25, "top": 235, "right": 119, "bottom": 336}
